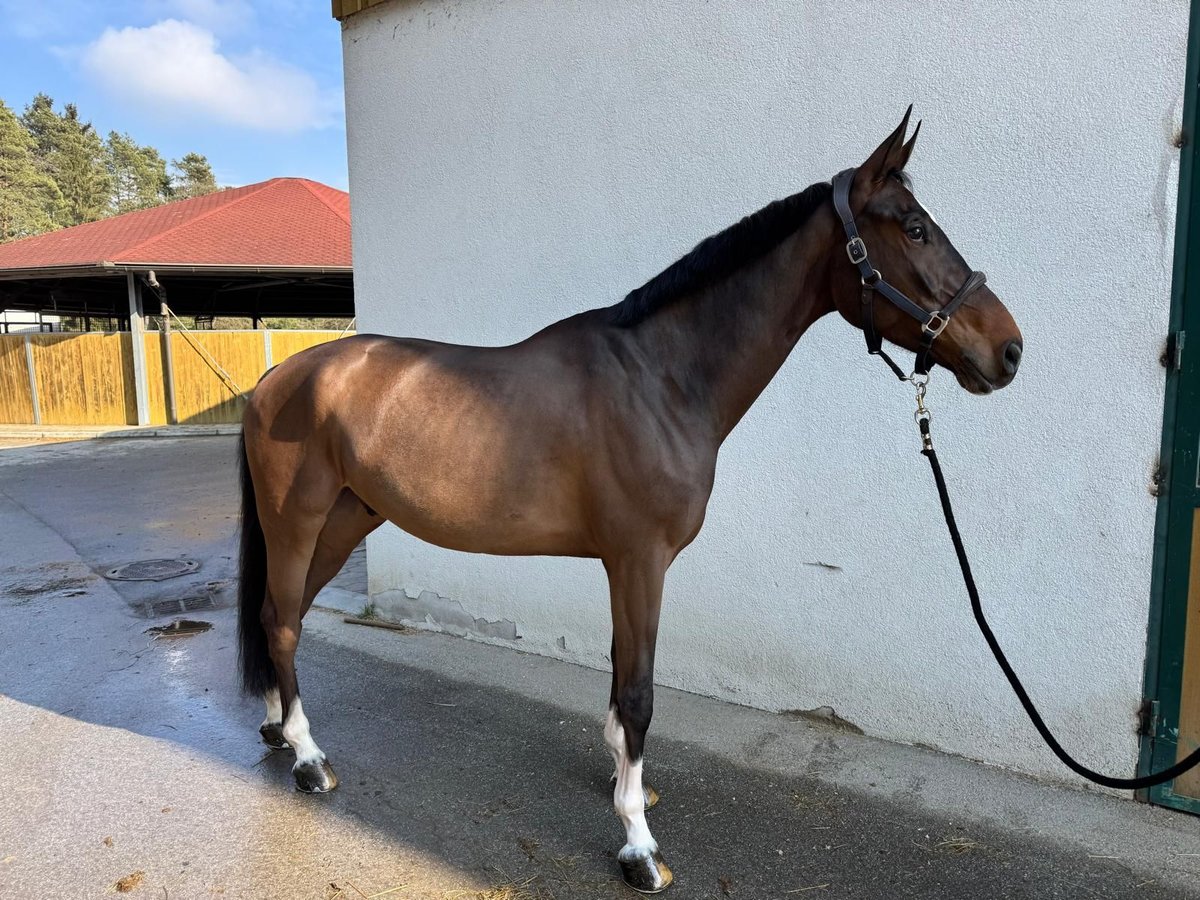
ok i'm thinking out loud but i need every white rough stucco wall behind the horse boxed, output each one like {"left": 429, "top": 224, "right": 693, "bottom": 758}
{"left": 344, "top": 0, "right": 1188, "bottom": 778}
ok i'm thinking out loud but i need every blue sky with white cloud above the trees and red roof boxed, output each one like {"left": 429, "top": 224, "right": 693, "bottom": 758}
{"left": 0, "top": 0, "right": 347, "bottom": 190}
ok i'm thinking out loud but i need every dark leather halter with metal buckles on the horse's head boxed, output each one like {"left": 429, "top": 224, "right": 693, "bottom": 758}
{"left": 833, "top": 169, "right": 988, "bottom": 382}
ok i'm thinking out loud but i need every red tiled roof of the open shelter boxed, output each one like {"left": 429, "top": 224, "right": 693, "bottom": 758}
{"left": 0, "top": 178, "right": 350, "bottom": 274}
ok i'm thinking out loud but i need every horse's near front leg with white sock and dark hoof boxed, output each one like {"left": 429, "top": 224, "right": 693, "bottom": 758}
{"left": 605, "top": 552, "right": 672, "bottom": 894}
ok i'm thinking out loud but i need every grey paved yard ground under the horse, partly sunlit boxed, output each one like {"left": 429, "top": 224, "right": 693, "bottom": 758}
{"left": 0, "top": 437, "right": 1200, "bottom": 900}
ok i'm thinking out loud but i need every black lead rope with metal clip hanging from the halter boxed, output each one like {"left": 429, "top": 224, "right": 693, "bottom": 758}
{"left": 914, "top": 382, "right": 1200, "bottom": 791}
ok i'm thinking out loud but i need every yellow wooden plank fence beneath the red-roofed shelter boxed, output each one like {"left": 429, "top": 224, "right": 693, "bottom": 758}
{"left": 0, "top": 331, "right": 346, "bottom": 425}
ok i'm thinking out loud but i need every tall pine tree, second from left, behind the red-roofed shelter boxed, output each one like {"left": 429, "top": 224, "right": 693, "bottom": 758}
{"left": 22, "top": 94, "right": 112, "bottom": 226}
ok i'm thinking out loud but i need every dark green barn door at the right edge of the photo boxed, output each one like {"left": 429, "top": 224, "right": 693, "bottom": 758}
{"left": 1141, "top": 5, "right": 1200, "bottom": 812}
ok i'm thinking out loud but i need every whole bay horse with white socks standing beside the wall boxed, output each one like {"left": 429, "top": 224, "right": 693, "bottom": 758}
{"left": 239, "top": 107, "right": 1022, "bottom": 893}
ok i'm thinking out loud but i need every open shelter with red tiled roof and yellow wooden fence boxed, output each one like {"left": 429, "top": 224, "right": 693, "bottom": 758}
{"left": 0, "top": 178, "right": 354, "bottom": 425}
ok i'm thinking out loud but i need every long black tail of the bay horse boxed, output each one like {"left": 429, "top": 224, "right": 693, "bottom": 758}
{"left": 238, "top": 430, "right": 276, "bottom": 696}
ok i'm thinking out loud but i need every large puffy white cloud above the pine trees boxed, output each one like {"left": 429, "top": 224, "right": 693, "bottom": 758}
{"left": 82, "top": 19, "right": 341, "bottom": 132}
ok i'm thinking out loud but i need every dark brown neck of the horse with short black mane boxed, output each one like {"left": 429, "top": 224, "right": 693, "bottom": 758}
{"left": 638, "top": 209, "right": 839, "bottom": 443}
